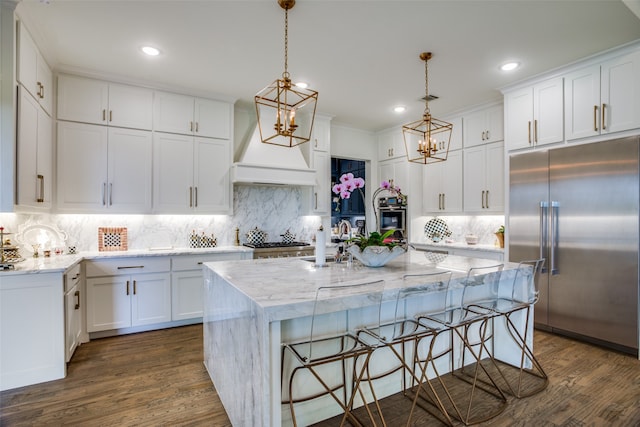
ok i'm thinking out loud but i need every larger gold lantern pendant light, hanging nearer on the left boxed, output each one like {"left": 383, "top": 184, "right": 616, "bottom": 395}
{"left": 255, "top": 0, "right": 318, "bottom": 147}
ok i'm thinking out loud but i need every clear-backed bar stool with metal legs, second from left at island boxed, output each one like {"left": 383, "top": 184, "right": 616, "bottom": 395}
{"left": 358, "top": 271, "right": 453, "bottom": 426}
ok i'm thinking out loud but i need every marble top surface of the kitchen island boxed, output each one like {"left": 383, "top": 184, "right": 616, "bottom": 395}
{"left": 204, "top": 251, "right": 517, "bottom": 320}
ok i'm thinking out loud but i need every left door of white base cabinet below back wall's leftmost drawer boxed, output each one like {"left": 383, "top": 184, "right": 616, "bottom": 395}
{"left": 87, "top": 276, "right": 133, "bottom": 332}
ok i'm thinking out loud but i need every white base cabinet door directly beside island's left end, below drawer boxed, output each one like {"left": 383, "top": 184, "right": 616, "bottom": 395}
{"left": 171, "top": 270, "right": 204, "bottom": 320}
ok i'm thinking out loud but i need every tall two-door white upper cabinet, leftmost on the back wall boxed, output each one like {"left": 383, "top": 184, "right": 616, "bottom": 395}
{"left": 57, "top": 122, "right": 152, "bottom": 213}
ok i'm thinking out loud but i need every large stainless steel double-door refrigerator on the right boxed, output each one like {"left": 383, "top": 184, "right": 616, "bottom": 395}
{"left": 507, "top": 137, "right": 640, "bottom": 354}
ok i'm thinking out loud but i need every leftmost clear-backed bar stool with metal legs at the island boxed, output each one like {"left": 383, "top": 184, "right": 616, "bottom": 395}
{"left": 281, "top": 280, "right": 385, "bottom": 426}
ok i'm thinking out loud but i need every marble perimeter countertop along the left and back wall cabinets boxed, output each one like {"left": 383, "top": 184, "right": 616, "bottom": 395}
{"left": 0, "top": 246, "right": 253, "bottom": 278}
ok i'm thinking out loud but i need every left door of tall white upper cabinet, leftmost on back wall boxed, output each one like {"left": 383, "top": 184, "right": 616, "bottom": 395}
{"left": 57, "top": 122, "right": 108, "bottom": 213}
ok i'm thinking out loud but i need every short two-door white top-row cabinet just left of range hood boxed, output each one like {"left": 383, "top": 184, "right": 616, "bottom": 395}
{"left": 153, "top": 91, "right": 233, "bottom": 139}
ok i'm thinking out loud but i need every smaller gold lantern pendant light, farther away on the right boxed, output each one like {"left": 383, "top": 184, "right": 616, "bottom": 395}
{"left": 402, "top": 52, "right": 453, "bottom": 165}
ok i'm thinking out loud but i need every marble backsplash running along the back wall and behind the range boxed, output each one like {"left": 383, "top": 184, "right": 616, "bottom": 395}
{"left": 0, "top": 186, "right": 328, "bottom": 251}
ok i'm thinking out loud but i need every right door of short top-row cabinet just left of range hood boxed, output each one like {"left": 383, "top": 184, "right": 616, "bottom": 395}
{"left": 193, "top": 98, "right": 232, "bottom": 139}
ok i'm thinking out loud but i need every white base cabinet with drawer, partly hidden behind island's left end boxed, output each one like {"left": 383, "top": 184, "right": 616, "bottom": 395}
{"left": 171, "top": 252, "right": 252, "bottom": 321}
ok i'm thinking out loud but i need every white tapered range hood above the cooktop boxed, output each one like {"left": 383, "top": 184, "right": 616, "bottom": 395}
{"left": 231, "top": 126, "right": 316, "bottom": 186}
